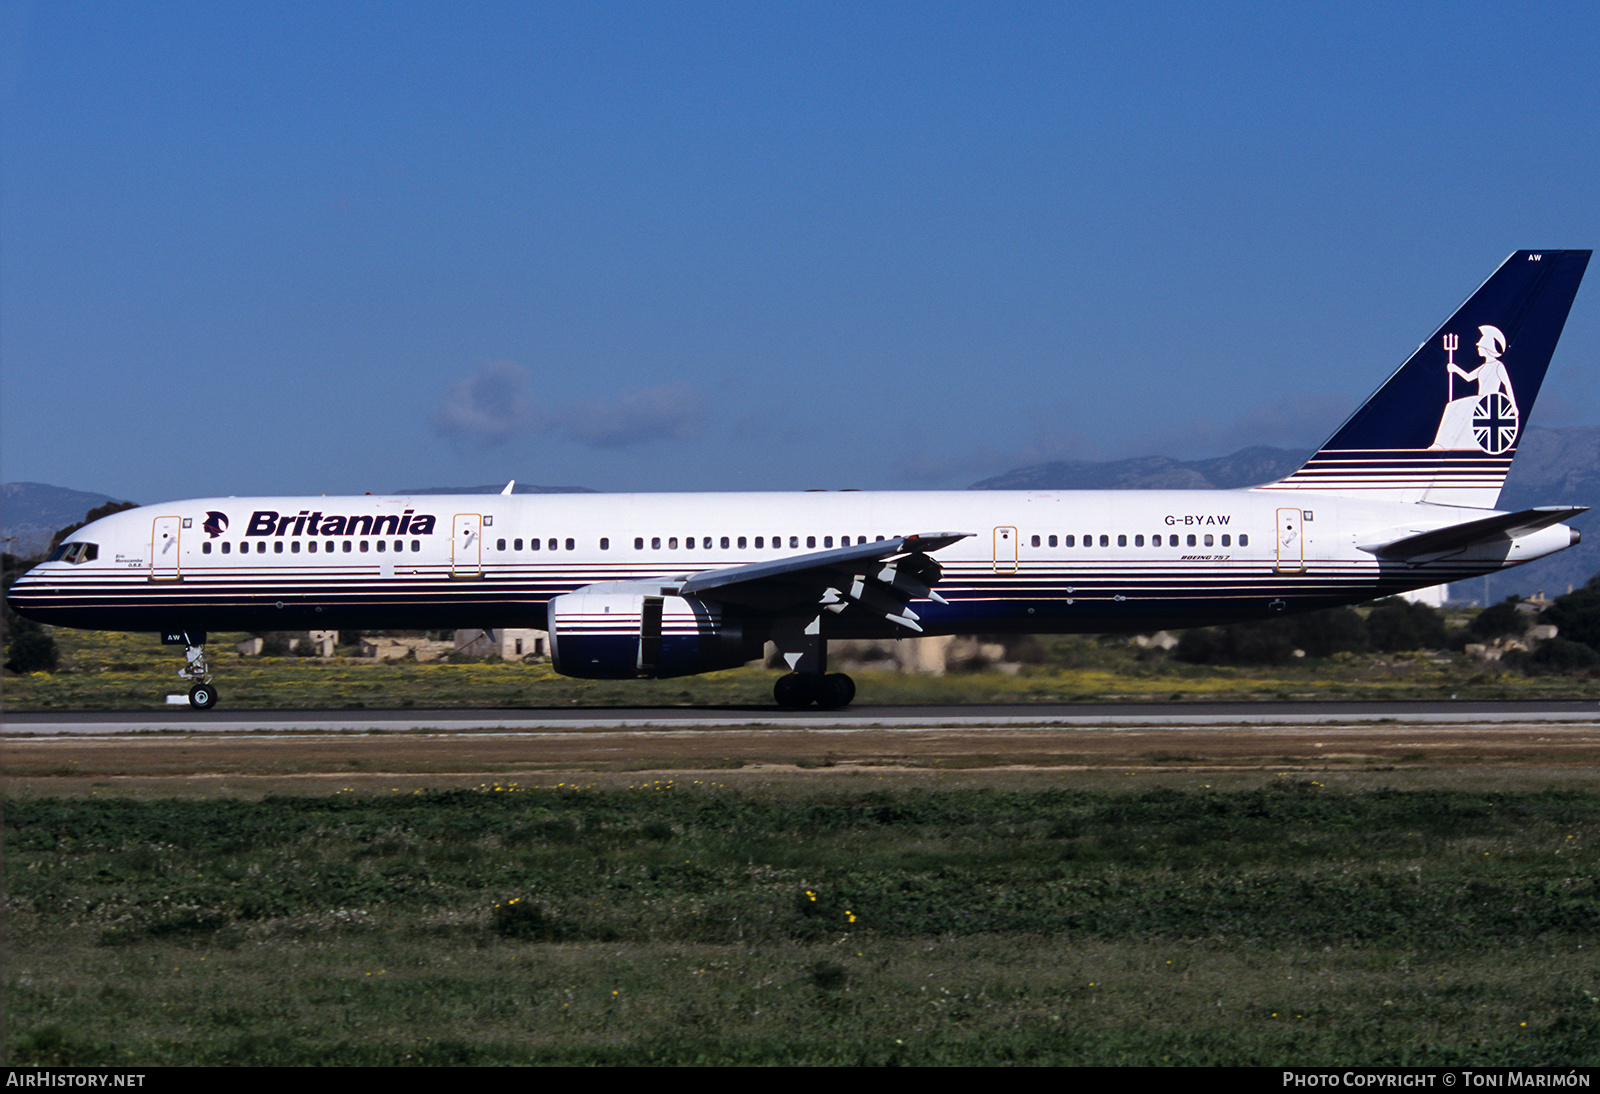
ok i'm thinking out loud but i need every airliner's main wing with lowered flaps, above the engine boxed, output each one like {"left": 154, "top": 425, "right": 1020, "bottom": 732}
{"left": 677, "top": 533, "right": 973, "bottom": 633}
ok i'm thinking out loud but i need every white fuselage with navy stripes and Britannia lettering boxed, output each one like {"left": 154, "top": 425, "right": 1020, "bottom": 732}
{"left": 11, "top": 489, "right": 1570, "bottom": 635}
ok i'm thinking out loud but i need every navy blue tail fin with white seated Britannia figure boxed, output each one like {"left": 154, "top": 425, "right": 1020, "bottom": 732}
{"left": 1266, "top": 251, "right": 1592, "bottom": 509}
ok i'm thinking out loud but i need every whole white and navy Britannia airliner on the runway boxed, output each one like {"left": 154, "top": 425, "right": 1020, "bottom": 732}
{"left": 8, "top": 251, "right": 1590, "bottom": 709}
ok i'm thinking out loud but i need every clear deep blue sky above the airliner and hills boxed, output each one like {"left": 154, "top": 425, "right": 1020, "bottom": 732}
{"left": 9, "top": 0, "right": 1600, "bottom": 502}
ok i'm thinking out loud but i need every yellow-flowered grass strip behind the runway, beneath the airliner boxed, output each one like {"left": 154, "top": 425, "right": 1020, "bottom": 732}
{"left": 3, "top": 629, "right": 1600, "bottom": 710}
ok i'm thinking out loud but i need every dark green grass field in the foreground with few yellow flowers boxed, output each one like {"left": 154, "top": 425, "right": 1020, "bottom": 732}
{"left": 5, "top": 768, "right": 1600, "bottom": 1067}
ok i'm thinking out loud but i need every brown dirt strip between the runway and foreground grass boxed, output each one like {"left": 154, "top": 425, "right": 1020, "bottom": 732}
{"left": 5, "top": 723, "right": 1600, "bottom": 793}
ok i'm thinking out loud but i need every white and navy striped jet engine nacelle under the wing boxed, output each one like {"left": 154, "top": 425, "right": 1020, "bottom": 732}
{"left": 549, "top": 582, "right": 763, "bottom": 680}
